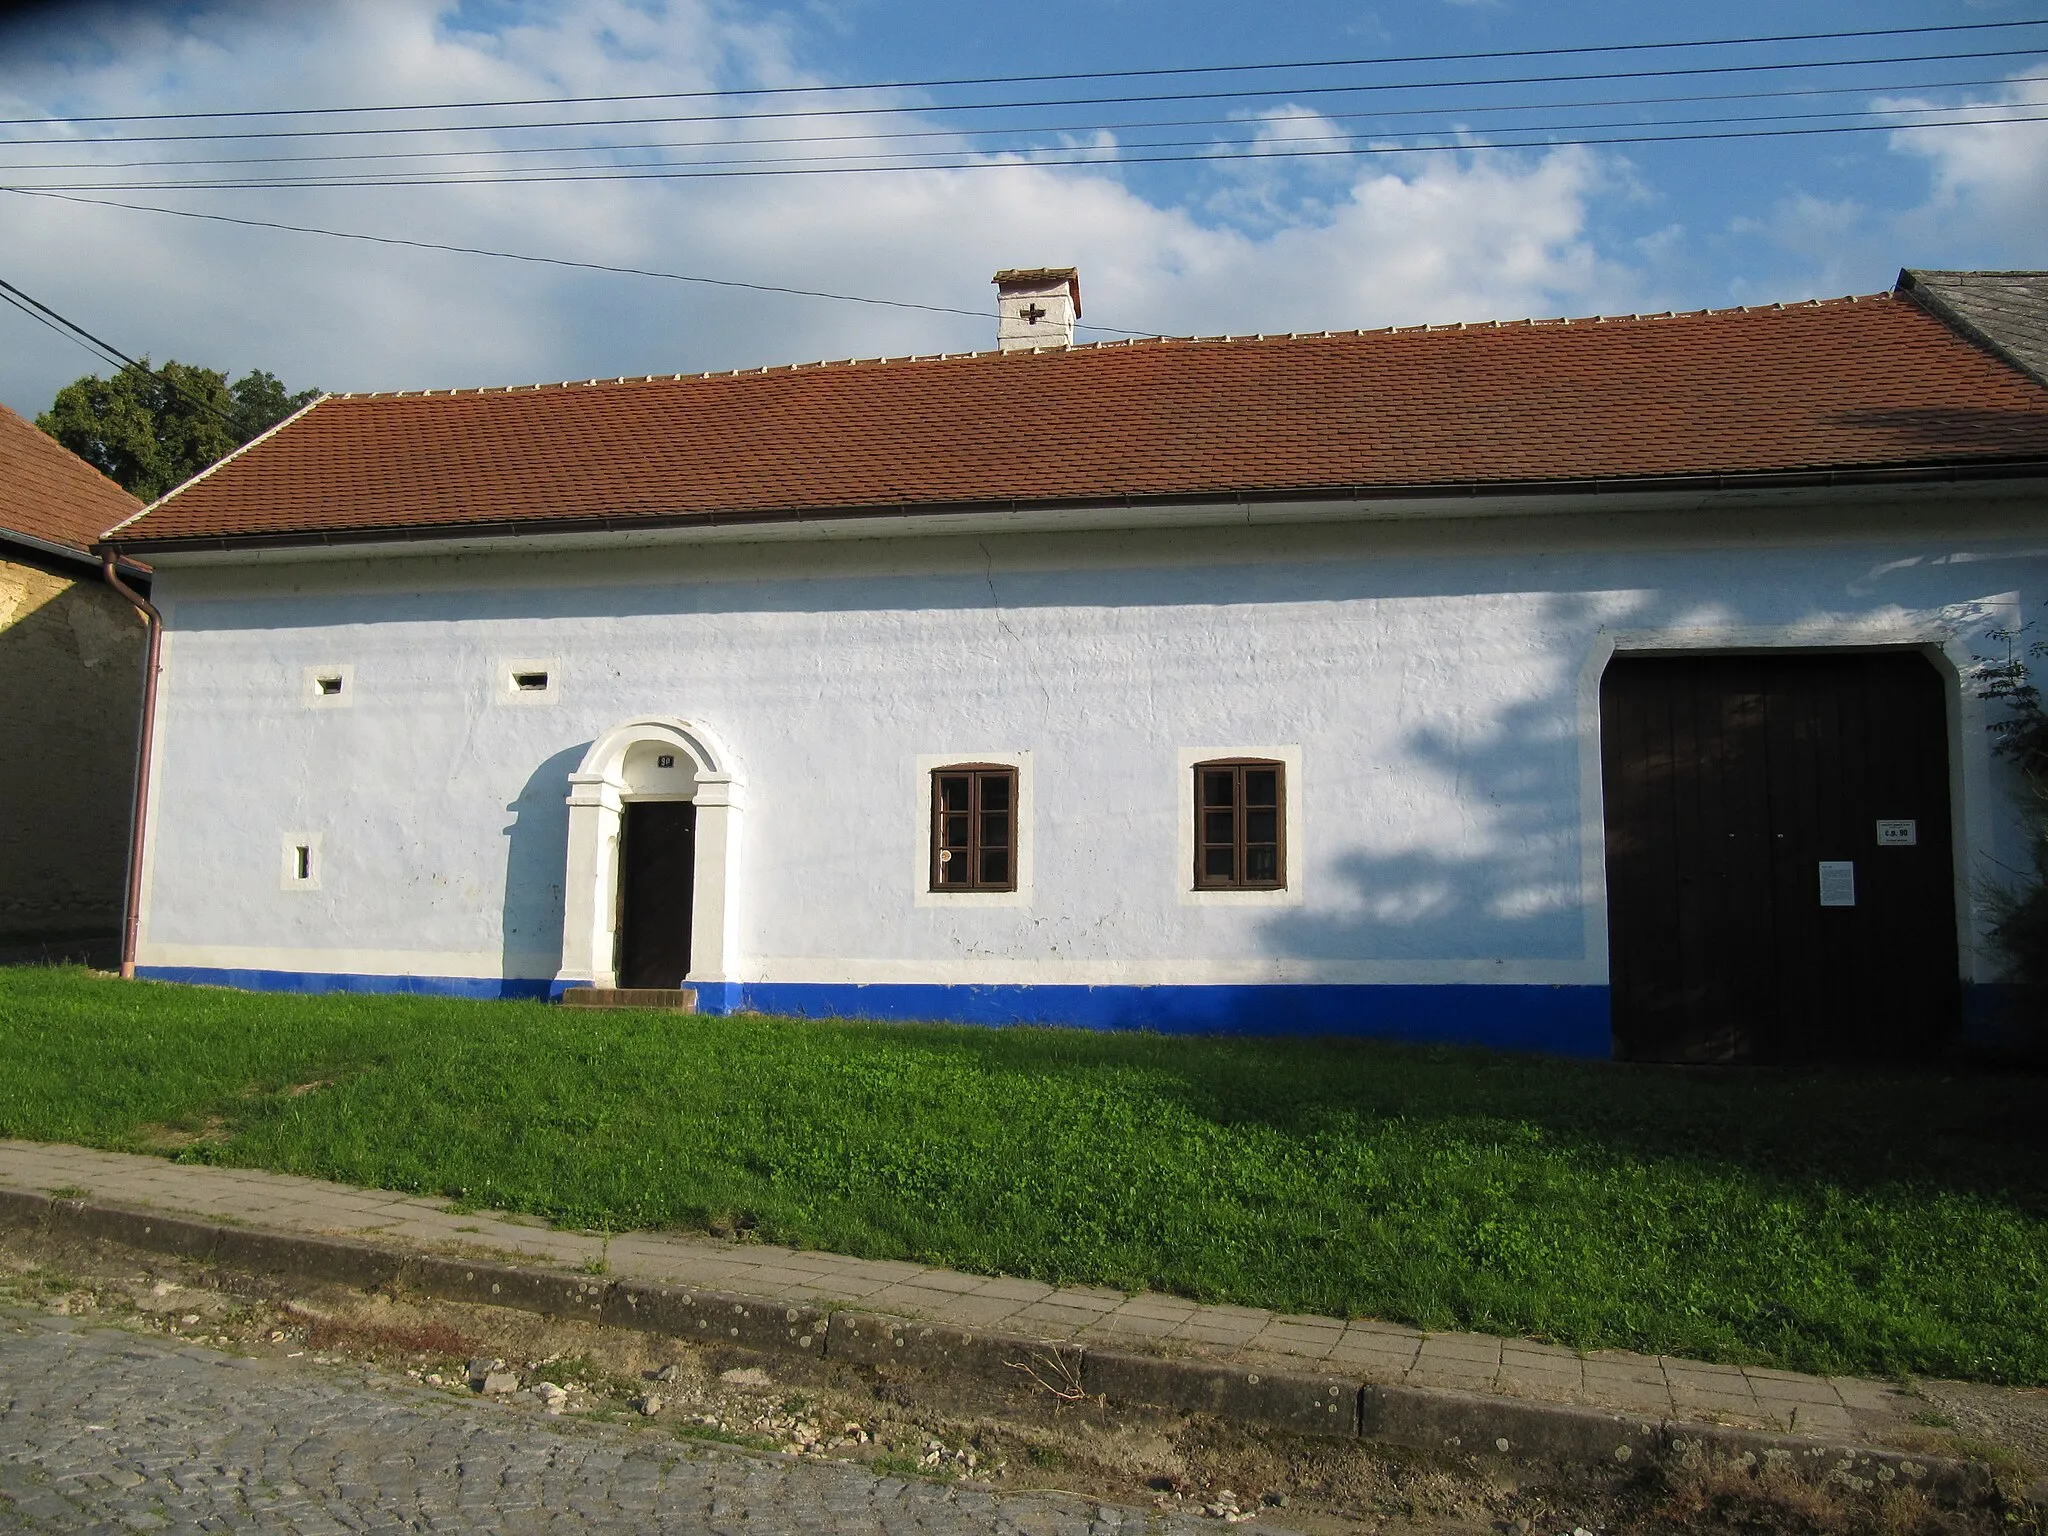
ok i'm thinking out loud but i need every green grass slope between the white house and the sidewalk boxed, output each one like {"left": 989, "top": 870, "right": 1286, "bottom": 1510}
{"left": 0, "top": 969, "right": 2048, "bottom": 1384}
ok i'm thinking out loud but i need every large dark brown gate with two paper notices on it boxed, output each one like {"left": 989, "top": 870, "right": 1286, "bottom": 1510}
{"left": 1599, "top": 651, "right": 1962, "bottom": 1063}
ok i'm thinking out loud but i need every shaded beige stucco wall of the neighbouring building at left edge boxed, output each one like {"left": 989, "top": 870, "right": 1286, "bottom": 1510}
{"left": 0, "top": 551, "right": 143, "bottom": 963}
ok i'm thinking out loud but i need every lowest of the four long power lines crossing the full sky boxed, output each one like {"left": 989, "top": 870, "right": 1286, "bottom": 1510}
{"left": 0, "top": 102, "right": 2048, "bottom": 193}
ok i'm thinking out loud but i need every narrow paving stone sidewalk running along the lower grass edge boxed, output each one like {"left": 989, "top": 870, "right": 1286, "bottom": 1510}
{"left": 0, "top": 1141, "right": 1919, "bottom": 1442}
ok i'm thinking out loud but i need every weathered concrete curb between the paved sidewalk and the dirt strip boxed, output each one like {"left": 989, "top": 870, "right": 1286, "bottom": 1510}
{"left": 0, "top": 1190, "right": 1997, "bottom": 1503}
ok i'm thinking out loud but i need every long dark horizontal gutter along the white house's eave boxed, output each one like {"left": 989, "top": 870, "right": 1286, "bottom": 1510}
{"left": 102, "top": 459, "right": 2048, "bottom": 555}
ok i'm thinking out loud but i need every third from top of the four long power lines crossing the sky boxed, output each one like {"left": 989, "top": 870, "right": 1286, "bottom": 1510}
{"left": 0, "top": 76, "right": 2030, "bottom": 170}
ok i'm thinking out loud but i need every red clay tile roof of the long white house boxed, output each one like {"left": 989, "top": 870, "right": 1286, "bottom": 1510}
{"left": 121, "top": 295, "right": 2048, "bottom": 545}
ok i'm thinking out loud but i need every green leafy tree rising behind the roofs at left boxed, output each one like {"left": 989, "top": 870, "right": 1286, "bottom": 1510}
{"left": 35, "top": 358, "right": 319, "bottom": 502}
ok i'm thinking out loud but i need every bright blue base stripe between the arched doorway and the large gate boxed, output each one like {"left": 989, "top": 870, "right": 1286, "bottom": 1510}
{"left": 741, "top": 981, "right": 1614, "bottom": 1057}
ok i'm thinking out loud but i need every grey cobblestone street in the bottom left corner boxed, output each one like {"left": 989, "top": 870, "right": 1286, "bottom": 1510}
{"left": 0, "top": 1309, "right": 1228, "bottom": 1536}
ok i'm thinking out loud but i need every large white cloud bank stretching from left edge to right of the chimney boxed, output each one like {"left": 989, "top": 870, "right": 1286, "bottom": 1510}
{"left": 0, "top": 0, "right": 1640, "bottom": 410}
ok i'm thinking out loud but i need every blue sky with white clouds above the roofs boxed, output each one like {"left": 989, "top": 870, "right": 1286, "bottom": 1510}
{"left": 0, "top": 0, "right": 2048, "bottom": 412}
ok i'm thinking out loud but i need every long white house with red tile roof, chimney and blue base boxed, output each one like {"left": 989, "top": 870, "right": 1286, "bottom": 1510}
{"left": 103, "top": 270, "right": 2048, "bottom": 1061}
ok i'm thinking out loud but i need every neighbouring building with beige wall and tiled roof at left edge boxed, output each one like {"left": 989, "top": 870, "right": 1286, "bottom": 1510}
{"left": 0, "top": 406, "right": 147, "bottom": 965}
